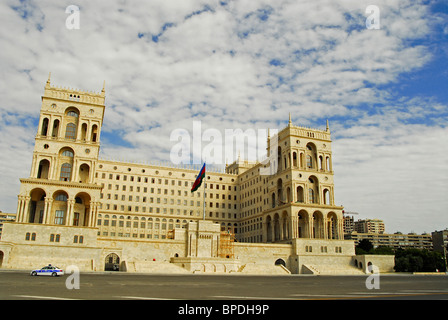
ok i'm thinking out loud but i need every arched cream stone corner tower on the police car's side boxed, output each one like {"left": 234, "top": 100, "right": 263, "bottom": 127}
{"left": 17, "top": 77, "right": 105, "bottom": 227}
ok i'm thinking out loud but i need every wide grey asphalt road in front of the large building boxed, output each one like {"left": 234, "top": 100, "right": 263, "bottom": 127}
{"left": 0, "top": 270, "right": 448, "bottom": 303}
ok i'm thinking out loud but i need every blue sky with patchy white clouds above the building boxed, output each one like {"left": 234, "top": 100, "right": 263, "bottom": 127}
{"left": 0, "top": 0, "right": 448, "bottom": 233}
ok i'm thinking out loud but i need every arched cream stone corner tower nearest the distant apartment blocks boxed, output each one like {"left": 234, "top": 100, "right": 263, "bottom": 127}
{"left": 263, "top": 117, "right": 343, "bottom": 242}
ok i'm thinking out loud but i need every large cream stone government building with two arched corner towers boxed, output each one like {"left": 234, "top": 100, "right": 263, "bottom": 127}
{"left": 0, "top": 78, "right": 392, "bottom": 273}
